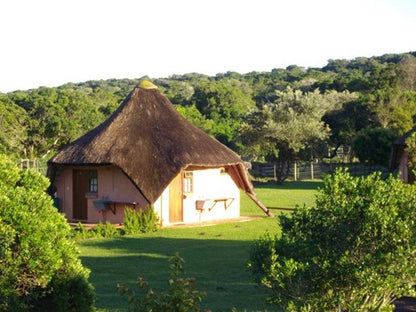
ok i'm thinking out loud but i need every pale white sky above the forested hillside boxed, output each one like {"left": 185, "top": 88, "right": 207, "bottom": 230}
{"left": 0, "top": 0, "right": 416, "bottom": 92}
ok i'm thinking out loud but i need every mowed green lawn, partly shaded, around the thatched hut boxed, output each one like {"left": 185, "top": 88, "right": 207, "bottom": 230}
{"left": 78, "top": 181, "right": 322, "bottom": 311}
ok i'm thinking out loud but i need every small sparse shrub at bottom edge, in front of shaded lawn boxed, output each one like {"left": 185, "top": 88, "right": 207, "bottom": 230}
{"left": 117, "top": 253, "right": 206, "bottom": 312}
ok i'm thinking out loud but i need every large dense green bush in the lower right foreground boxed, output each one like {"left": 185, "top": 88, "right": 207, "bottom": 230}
{"left": 250, "top": 170, "right": 416, "bottom": 311}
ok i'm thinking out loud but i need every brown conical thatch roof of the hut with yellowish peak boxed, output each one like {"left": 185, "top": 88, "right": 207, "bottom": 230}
{"left": 48, "top": 82, "right": 254, "bottom": 203}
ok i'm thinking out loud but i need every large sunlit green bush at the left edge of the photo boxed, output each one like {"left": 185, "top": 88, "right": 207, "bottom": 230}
{"left": 0, "top": 155, "right": 94, "bottom": 311}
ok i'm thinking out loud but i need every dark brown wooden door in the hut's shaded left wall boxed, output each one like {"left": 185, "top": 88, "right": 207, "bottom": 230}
{"left": 72, "top": 170, "right": 90, "bottom": 220}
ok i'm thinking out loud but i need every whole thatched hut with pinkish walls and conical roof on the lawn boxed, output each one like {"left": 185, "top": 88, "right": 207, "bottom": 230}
{"left": 48, "top": 81, "right": 269, "bottom": 225}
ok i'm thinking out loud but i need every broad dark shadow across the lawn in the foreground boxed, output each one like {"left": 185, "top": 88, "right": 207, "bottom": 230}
{"left": 80, "top": 236, "right": 276, "bottom": 311}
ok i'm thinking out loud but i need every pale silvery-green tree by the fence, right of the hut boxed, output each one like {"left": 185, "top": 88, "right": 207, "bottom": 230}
{"left": 241, "top": 87, "right": 335, "bottom": 180}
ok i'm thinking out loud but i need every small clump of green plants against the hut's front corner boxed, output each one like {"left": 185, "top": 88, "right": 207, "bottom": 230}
{"left": 124, "top": 207, "right": 160, "bottom": 234}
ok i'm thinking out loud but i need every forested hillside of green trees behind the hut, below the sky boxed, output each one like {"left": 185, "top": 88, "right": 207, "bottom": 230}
{"left": 0, "top": 52, "right": 416, "bottom": 174}
